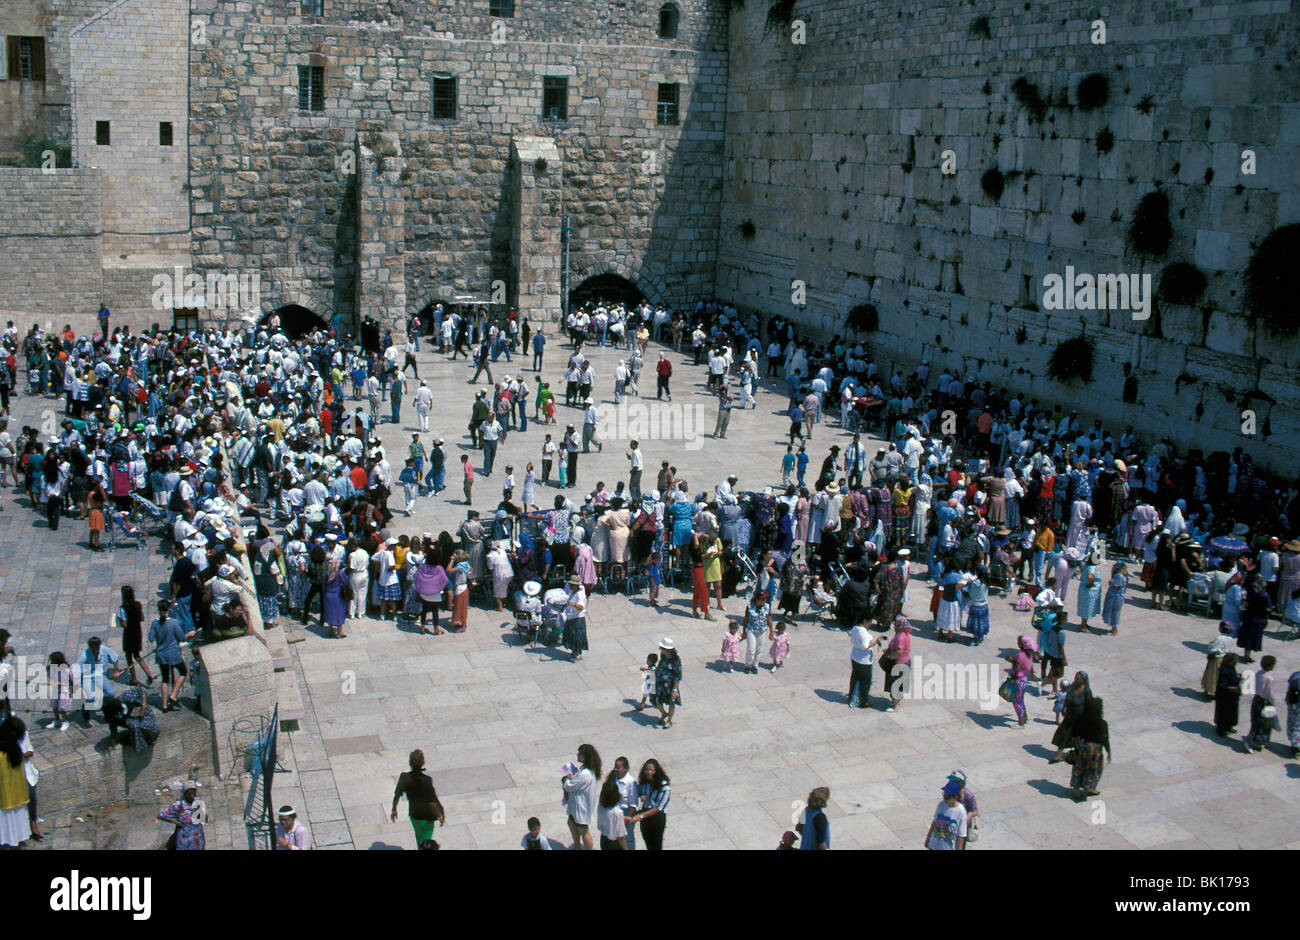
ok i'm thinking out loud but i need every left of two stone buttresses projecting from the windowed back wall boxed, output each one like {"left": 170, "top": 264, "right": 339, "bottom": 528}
{"left": 356, "top": 130, "right": 406, "bottom": 346}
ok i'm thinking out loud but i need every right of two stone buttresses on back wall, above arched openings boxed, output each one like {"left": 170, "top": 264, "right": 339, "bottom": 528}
{"left": 510, "top": 137, "right": 564, "bottom": 324}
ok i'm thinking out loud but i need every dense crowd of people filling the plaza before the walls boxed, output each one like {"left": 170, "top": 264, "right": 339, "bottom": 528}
{"left": 0, "top": 302, "right": 1300, "bottom": 848}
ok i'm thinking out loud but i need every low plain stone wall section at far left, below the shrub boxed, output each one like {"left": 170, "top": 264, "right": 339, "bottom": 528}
{"left": 0, "top": 168, "right": 103, "bottom": 330}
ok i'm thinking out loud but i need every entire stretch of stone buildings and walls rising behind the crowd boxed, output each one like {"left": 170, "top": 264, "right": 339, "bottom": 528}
{"left": 0, "top": 0, "right": 1300, "bottom": 469}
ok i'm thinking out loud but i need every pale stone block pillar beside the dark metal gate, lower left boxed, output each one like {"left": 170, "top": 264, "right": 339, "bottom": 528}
{"left": 194, "top": 636, "right": 276, "bottom": 774}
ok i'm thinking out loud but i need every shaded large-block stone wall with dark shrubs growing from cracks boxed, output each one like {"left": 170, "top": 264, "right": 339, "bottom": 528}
{"left": 718, "top": 0, "right": 1300, "bottom": 472}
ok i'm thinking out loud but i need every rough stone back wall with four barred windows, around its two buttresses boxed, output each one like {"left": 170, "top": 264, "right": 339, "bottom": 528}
{"left": 190, "top": 0, "right": 727, "bottom": 327}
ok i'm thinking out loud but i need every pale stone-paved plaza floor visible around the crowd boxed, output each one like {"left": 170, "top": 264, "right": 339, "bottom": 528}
{"left": 0, "top": 337, "right": 1300, "bottom": 849}
